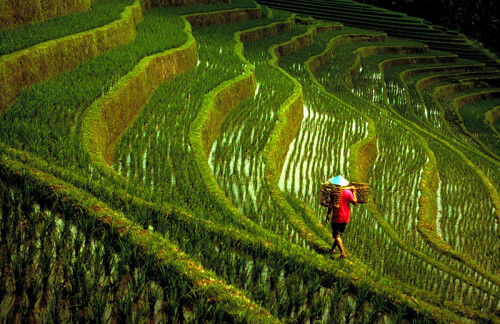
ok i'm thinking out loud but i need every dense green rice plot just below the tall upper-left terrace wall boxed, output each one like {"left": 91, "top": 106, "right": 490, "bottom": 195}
{"left": 0, "top": 5, "right": 185, "bottom": 169}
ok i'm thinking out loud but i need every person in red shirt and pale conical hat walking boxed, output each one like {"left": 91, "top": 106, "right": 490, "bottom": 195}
{"left": 326, "top": 175, "right": 358, "bottom": 258}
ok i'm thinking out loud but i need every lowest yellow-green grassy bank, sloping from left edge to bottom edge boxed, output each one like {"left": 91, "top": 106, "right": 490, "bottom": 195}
{"left": 0, "top": 149, "right": 278, "bottom": 323}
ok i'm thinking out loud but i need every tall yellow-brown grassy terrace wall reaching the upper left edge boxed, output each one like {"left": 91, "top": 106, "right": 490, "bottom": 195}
{"left": 0, "top": 0, "right": 143, "bottom": 113}
